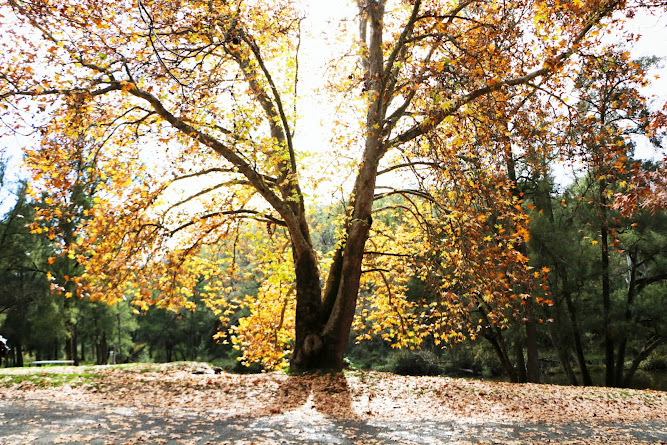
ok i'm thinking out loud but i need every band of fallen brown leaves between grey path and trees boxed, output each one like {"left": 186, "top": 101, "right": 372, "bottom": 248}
{"left": 0, "top": 362, "right": 667, "bottom": 443}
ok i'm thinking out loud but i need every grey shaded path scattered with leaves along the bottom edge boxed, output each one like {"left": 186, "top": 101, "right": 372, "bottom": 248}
{"left": 0, "top": 399, "right": 667, "bottom": 445}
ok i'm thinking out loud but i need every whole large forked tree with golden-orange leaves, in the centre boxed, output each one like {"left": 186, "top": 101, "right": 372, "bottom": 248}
{"left": 0, "top": 0, "right": 660, "bottom": 369}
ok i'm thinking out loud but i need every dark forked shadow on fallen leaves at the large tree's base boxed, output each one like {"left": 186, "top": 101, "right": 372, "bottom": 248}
{"left": 270, "top": 372, "right": 360, "bottom": 420}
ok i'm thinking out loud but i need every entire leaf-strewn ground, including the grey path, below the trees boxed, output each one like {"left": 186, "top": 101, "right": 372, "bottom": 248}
{"left": 0, "top": 363, "right": 667, "bottom": 444}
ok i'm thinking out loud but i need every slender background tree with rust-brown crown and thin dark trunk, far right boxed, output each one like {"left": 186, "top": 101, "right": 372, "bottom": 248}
{"left": 571, "top": 51, "right": 664, "bottom": 386}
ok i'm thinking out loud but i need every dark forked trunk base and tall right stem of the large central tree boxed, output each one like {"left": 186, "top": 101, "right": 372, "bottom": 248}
{"left": 290, "top": 0, "right": 386, "bottom": 371}
